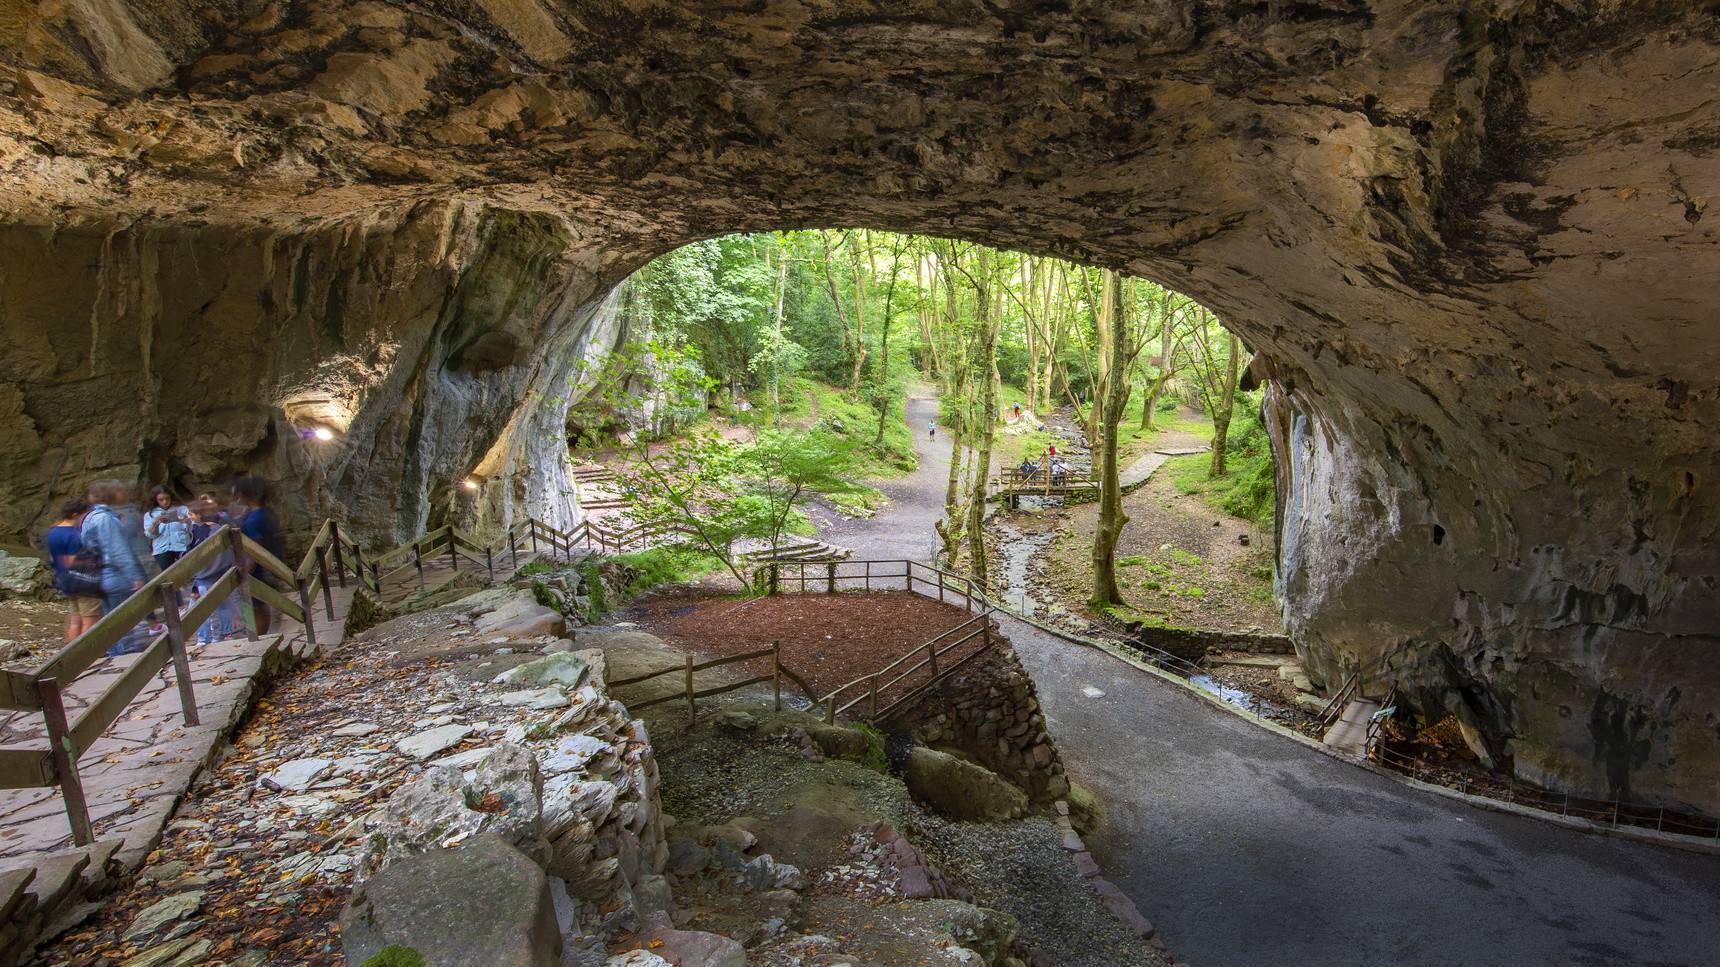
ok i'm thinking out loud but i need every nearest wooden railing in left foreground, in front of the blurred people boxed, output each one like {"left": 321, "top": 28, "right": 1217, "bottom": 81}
{"left": 0, "top": 527, "right": 316, "bottom": 845}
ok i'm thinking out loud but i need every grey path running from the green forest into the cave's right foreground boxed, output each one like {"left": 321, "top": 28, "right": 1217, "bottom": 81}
{"left": 824, "top": 387, "right": 1720, "bottom": 967}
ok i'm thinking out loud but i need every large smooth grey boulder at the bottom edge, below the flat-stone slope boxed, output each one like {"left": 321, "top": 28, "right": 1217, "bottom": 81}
{"left": 341, "top": 833, "right": 562, "bottom": 967}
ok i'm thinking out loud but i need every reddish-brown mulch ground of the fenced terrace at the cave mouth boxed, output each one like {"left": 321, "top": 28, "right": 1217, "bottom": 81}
{"left": 619, "top": 590, "right": 979, "bottom": 697}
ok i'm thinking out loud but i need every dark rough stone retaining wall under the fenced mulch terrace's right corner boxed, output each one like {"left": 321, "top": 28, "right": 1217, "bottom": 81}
{"left": 888, "top": 645, "right": 1070, "bottom": 807}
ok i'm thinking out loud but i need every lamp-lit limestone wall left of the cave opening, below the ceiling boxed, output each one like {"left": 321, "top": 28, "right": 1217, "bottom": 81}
{"left": 0, "top": 200, "right": 623, "bottom": 544}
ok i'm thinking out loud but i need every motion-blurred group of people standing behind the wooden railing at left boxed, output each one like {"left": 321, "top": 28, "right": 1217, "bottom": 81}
{"left": 43, "top": 477, "right": 280, "bottom": 656}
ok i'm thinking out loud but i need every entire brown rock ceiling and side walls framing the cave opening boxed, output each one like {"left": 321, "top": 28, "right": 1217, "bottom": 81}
{"left": 0, "top": 0, "right": 1720, "bottom": 809}
